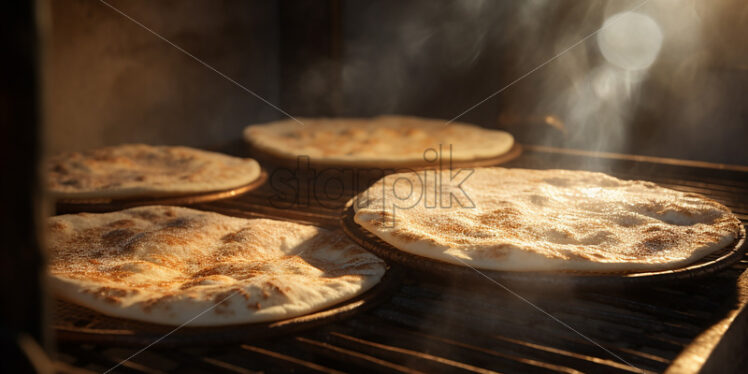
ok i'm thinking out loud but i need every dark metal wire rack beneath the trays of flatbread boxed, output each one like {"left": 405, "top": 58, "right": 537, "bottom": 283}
{"left": 58, "top": 146, "right": 748, "bottom": 373}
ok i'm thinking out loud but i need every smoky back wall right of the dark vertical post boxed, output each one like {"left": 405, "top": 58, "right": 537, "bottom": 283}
{"left": 342, "top": 0, "right": 748, "bottom": 164}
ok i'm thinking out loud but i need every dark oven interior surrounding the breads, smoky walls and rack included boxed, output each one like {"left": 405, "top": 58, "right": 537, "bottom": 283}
{"left": 0, "top": 0, "right": 748, "bottom": 373}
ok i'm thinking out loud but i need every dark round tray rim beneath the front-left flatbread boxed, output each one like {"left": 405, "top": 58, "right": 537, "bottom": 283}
{"left": 52, "top": 265, "right": 403, "bottom": 346}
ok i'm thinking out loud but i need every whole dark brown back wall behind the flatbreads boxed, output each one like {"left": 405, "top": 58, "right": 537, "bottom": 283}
{"left": 46, "top": 0, "right": 748, "bottom": 164}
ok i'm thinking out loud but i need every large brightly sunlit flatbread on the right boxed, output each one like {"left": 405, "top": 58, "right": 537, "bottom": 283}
{"left": 354, "top": 168, "right": 741, "bottom": 272}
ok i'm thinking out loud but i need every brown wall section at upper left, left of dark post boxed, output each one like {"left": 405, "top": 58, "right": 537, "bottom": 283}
{"left": 45, "top": 0, "right": 279, "bottom": 152}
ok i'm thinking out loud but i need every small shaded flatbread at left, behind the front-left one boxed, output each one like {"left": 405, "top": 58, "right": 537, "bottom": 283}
{"left": 47, "top": 144, "right": 260, "bottom": 199}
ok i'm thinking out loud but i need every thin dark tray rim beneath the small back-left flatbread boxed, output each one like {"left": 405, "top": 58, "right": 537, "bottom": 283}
{"left": 55, "top": 170, "right": 268, "bottom": 214}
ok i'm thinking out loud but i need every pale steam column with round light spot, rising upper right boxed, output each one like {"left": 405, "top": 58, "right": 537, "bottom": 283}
{"left": 539, "top": 2, "right": 664, "bottom": 156}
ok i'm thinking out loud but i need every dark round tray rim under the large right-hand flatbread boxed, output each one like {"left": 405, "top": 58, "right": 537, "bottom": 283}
{"left": 341, "top": 197, "right": 748, "bottom": 288}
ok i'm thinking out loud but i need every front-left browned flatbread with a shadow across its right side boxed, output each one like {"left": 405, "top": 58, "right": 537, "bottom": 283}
{"left": 48, "top": 206, "right": 385, "bottom": 326}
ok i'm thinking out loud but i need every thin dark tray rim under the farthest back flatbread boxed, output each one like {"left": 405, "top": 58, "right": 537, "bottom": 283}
{"left": 247, "top": 143, "right": 522, "bottom": 172}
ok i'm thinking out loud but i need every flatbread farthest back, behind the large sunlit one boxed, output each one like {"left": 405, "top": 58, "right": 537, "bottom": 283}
{"left": 244, "top": 116, "right": 514, "bottom": 167}
